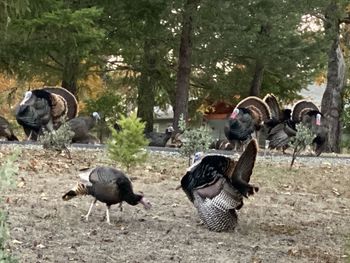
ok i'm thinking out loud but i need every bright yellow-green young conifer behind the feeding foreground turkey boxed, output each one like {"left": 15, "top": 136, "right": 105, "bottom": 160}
{"left": 107, "top": 113, "right": 149, "bottom": 170}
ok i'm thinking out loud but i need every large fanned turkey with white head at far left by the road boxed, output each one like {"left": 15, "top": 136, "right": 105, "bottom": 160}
{"left": 16, "top": 87, "right": 78, "bottom": 140}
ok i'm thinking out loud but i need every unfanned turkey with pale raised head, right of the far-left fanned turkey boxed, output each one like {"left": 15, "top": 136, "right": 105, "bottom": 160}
{"left": 68, "top": 112, "right": 101, "bottom": 143}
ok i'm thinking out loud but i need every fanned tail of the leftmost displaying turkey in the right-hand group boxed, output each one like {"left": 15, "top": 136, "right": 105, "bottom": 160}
{"left": 236, "top": 96, "right": 271, "bottom": 122}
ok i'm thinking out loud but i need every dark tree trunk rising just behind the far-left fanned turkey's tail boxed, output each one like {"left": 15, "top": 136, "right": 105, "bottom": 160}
{"left": 61, "top": 56, "right": 79, "bottom": 97}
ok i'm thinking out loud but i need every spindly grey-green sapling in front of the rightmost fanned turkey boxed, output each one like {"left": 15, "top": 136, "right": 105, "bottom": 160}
{"left": 289, "top": 123, "right": 315, "bottom": 168}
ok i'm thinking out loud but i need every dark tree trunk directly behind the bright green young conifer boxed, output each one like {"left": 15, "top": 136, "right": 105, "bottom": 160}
{"left": 137, "top": 39, "right": 157, "bottom": 132}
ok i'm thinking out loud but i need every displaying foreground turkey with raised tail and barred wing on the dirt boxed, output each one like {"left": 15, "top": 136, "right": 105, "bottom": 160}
{"left": 181, "top": 140, "right": 259, "bottom": 232}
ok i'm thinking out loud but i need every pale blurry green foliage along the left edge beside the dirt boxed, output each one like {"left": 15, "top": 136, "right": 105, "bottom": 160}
{"left": 0, "top": 149, "right": 20, "bottom": 263}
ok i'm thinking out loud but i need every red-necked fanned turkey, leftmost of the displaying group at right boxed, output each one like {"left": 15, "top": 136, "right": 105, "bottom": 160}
{"left": 224, "top": 96, "right": 271, "bottom": 147}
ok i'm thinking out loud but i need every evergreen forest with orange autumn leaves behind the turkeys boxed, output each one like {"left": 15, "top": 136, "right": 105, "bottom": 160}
{"left": 0, "top": 0, "right": 350, "bottom": 152}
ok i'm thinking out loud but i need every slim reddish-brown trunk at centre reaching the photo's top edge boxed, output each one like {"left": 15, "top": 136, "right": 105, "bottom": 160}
{"left": 173, "top": 0, "right": 199, "bottom": 131}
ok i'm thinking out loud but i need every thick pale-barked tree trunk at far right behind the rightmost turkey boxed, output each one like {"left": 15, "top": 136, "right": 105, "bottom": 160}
{"left": 321, "top": 2, "right": 345, "bottom": 153}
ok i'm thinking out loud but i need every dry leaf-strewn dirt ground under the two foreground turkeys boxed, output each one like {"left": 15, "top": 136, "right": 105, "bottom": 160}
{"left": 0, "top": 147, "right": 350, "bottom": 263}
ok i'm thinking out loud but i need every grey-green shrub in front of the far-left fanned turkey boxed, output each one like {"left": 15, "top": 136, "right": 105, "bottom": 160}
{"left": 39, "top": 122, "right": 74, "bottom": 156}
